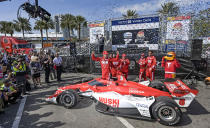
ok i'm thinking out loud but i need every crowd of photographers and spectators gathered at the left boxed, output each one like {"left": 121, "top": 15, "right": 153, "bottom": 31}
{"left": 0, "top": 50, "right": 62, "bottom": 114}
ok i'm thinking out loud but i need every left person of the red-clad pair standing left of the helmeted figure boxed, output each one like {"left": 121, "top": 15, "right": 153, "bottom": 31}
{"left": 137, "top": 53, "right": 146, "bottom": 82}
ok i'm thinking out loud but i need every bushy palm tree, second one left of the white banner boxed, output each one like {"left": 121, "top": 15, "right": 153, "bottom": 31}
{"left": 61, "top": 14, "right": 75, "bottom": 38}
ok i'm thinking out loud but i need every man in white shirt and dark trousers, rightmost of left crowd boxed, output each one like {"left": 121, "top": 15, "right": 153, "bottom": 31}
{"left": 53, "top": 53, "right": 63, "bottom": 82}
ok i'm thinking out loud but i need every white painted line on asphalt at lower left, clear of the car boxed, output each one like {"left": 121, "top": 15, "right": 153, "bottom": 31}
{"left": 12, "top": 96, "right": 27, "bottom": 128}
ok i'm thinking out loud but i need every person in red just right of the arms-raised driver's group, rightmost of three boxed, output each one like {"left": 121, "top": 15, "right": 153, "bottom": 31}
{"left": 118, "top": 54, "right": 130, "bottom": 79}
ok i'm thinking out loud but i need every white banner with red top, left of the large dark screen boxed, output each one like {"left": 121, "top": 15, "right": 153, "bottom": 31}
{"left": 88, "top": 23, "right": 104, "bottom": 43}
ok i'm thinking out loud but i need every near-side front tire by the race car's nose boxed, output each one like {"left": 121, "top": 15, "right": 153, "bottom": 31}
{"left": 59, "top": 90, "right": 79, "bottom": 109}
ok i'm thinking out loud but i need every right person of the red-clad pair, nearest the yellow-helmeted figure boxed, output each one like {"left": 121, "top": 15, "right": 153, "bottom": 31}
{"left": 146, "top": 51, "right": 156, "bottom": 81}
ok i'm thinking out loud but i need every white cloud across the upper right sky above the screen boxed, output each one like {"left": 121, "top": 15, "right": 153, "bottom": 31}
{"left": 113, "top": 0, "right": 209, "bottom": 14}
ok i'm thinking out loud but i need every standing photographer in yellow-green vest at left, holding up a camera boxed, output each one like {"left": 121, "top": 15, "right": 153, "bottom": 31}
{"left": 12, "top": 56, "right": 26, "bottom": 95}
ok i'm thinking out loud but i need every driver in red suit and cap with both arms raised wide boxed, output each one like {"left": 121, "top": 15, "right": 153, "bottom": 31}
{"left": 91, "top": 51, "right": 119, "bottom": 80}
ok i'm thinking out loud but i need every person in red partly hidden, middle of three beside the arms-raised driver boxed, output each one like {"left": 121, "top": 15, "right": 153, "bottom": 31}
{"left": 110, "top": 54, "right": 119, "bottom": 77}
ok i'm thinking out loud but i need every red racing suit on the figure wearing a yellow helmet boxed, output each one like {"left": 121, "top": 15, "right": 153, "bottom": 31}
{"left": 161, "top": 57, "right": 181, "bottom": 79}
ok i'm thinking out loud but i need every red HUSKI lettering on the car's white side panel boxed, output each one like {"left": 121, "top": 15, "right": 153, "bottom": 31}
{"left": 99, "top": 97, "right": 120, "bottom": 108}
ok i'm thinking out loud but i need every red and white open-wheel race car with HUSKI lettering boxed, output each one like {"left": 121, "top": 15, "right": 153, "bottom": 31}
{"left": 45, "top": 76, "right": 198, "bottom": 125}
